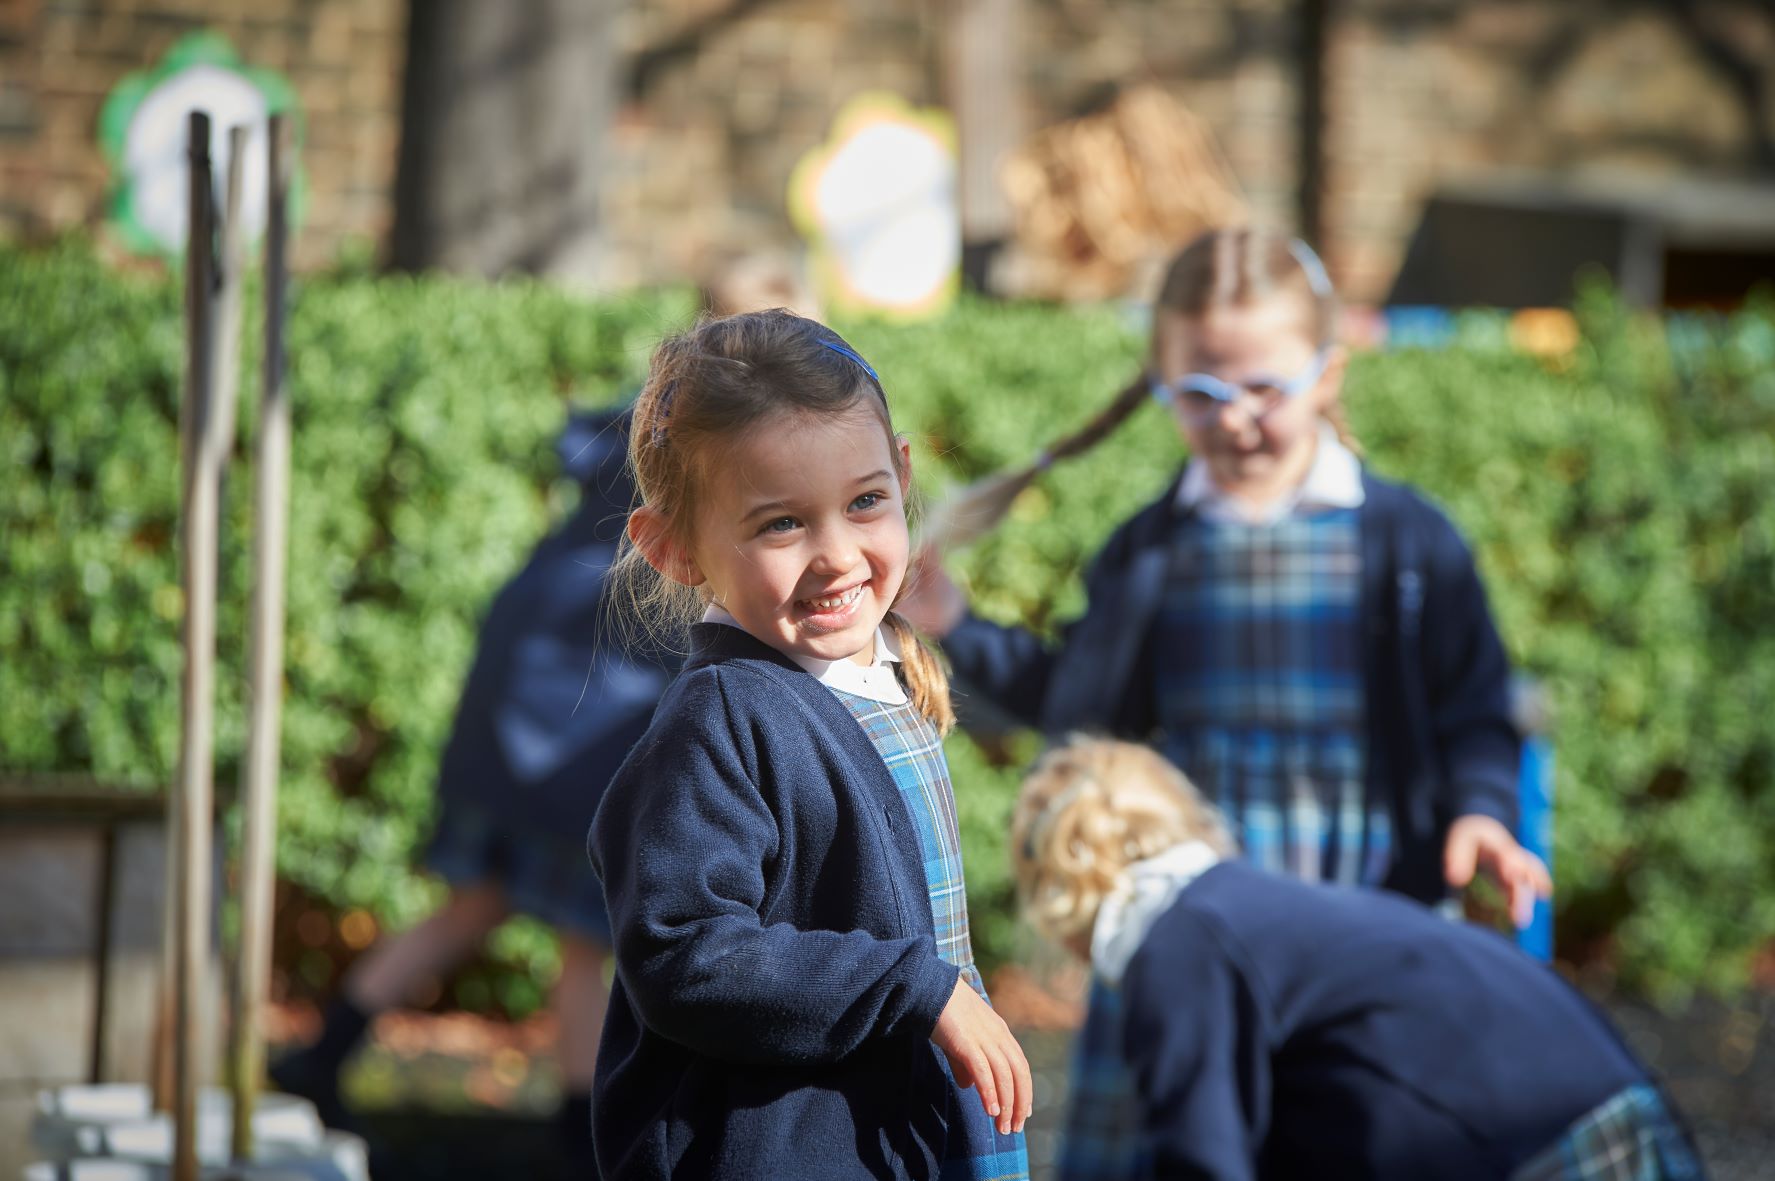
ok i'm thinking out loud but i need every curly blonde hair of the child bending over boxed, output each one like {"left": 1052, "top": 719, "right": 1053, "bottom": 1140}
{"left": 1010, "top": 737, "right": 1239, "bottom": 943}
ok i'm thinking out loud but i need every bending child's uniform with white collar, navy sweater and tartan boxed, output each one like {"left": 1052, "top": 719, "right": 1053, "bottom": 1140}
{"left": 1060, "top": 842, "right": 1702, "bottom": 1181}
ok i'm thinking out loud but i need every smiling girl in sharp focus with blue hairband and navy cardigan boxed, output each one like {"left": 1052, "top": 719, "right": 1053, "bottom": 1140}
{"left": 589, "top": 311, "right": 1031, "bottom": 1181}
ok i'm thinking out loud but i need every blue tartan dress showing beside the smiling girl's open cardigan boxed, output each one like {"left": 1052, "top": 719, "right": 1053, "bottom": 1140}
{"left": 832, "top": 689, "right": 1030, "bottom": 1181}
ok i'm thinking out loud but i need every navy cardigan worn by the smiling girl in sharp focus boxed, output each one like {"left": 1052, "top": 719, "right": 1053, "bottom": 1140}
{"left": 589, "top": 623, "right": 971, "bottom": 1181}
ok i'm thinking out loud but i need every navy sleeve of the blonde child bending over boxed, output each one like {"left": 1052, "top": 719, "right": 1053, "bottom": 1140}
{"left": 1122, "top": 913, "right": 1271, "bottom": 1181}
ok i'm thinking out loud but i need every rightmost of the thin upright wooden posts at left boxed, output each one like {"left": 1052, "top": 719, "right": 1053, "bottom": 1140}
{"left": 229, "top": 115, "right": 291, "bottom": 1161}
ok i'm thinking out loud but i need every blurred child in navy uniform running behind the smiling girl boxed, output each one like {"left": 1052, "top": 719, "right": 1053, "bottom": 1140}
{"left": 272, "top": 408, "right": 675, "bottom": 1153}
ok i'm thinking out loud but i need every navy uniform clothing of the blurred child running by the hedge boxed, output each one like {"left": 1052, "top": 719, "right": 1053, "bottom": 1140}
{"left": 424, "top": 408, "right": 676, "bottom": 943}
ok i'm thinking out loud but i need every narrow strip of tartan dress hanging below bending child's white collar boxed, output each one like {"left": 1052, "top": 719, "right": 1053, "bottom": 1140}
{"left": 1060, "top": 975, "right": 1152, "bottom": 1181}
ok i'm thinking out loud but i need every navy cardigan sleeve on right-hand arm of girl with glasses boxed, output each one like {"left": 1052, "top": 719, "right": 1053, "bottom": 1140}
{"left": 1422, "top": 513, "right": 1521, "bottom": 831}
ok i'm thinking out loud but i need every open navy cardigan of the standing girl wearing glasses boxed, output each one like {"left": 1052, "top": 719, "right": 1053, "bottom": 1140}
{"left": 943, "top": 471, "right": 1521, "bottom": 902}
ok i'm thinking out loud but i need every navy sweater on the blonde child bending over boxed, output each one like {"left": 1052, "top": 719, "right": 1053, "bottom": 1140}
{"left": 1118, "top": 863, "right": 1647, "bottom": 1181}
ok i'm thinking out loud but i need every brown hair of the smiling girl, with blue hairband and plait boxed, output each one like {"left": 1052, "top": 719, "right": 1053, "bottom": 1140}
{"left": 612, "top": 307, "right": 955, "bottom": 733}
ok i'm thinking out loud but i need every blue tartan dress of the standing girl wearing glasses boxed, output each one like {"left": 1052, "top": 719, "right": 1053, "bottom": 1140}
{"left": 1154, "top": 508, "right": 1392, "bottom": 884}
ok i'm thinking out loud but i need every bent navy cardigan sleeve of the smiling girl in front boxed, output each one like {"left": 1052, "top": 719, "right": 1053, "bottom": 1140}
{"left": 591, "top": 671, "right": 957, "bottom": 1064}
